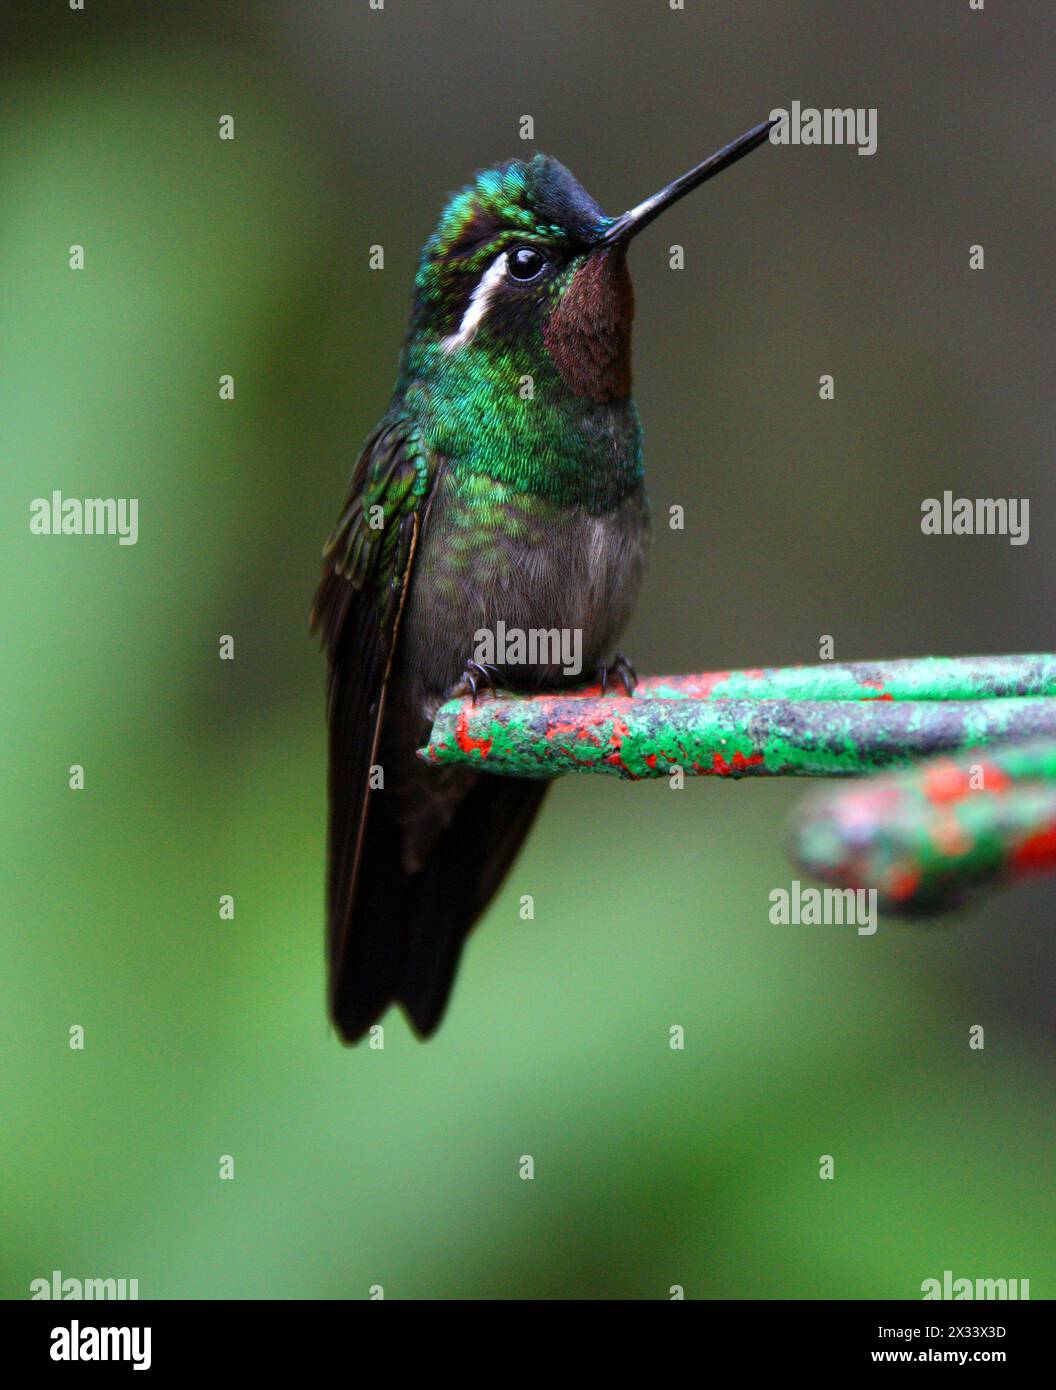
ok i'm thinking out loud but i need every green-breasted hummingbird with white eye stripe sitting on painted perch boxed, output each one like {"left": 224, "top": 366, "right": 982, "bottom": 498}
{"left": 311, "top": 121, "right": 775, "bottom": 1043}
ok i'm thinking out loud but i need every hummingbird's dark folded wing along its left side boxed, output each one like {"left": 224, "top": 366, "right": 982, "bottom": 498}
{"left": 311, "top": 413, "right": 436, "bottom": 1036}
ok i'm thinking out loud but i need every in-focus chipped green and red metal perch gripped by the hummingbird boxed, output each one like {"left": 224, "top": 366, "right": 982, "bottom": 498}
{"left": 420, "top": 655, "right": 1056, "bottom": 780}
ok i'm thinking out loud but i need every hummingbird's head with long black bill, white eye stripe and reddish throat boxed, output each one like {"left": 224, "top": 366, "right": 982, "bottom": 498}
{"left": 403, "top": 122, "right": 773, "bottom": 402}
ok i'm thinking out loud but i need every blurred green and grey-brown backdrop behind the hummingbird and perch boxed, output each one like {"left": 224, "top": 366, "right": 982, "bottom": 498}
{"left": 0, "top": 0, "right": 1056, "bottom": 1298}
